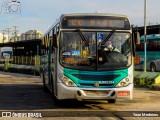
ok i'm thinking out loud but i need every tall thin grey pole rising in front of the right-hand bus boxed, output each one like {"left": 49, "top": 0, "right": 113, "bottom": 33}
{"left": 144, "top": 0, "right": 147, "bottom": 72}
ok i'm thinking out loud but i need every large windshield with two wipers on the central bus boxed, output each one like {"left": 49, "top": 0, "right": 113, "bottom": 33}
{"left": 60, "top": 31, "right": 131, "bottom": 70}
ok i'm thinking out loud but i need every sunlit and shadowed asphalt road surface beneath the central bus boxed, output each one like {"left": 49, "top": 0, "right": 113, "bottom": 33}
{"left": 0, "top": 72, "right": 160, "bottom": 120}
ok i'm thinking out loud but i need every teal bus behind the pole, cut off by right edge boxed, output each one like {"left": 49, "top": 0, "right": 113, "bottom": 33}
{"left": 135, "top": 34, "right": 160, "bottom": 72}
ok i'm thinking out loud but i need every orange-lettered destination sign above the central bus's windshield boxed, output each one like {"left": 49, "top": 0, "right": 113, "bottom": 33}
{"left": 62, "top": 17, "right": 130, "bottom": 29}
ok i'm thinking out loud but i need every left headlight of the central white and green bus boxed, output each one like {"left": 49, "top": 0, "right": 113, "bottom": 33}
{"left": 59, "top": 74, "right": 76, "bottom": 87}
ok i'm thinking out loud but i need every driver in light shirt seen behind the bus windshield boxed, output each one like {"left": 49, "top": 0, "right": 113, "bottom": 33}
{"left": 104, "top": 41, "right": 120, "bottom": 53}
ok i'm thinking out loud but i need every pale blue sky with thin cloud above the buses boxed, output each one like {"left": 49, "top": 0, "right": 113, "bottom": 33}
{"left": 0, "top": 0, "right": 160, "bottom": 33}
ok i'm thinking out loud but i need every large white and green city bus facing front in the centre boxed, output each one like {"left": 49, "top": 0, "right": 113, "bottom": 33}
{"left": 41, "top": 13, "right": 138, "bottom": 103}
